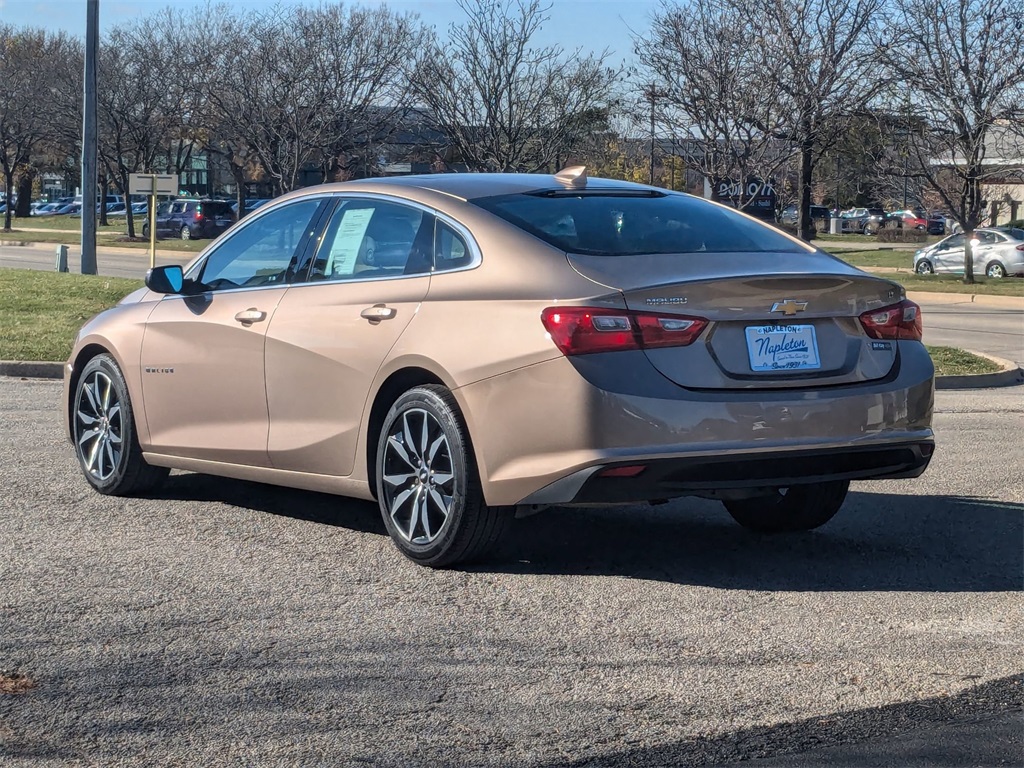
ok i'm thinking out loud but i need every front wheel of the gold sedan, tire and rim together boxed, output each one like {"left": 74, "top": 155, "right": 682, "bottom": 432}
{"left": 71, "top": 354, "right": 169, "bottom": 496}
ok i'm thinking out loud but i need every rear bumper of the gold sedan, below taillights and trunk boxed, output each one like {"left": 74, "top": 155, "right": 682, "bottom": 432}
{"left": 456, "top": 342, "right": 934, "bottom": 505}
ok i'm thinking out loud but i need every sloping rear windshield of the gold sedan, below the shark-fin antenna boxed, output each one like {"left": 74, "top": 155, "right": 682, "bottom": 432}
{"left": 473, "top": 191, "right": 802, "bottom": 256}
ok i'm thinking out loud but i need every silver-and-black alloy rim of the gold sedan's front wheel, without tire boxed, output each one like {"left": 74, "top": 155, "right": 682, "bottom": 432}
{"left": 75, "top": 371, "right": 124, "bottom": 482}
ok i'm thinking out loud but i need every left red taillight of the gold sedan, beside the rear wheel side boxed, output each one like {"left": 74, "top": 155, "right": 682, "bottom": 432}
{"left": 541, "top": 306, "right": 708, "bottom": 355}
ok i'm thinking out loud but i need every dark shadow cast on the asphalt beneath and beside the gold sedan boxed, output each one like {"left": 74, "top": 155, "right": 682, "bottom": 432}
{"left": 153, "top": 473, "right": 1024, "bottom": 592}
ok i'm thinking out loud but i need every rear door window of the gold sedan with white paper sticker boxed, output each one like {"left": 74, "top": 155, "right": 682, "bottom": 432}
{"left": 310, "top": 199, "right": 433, "bottom": 280}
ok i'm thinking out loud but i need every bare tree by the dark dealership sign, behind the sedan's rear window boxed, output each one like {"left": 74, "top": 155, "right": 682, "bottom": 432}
{"left": 635, "top": 0, "right": 793, "bottom": 208}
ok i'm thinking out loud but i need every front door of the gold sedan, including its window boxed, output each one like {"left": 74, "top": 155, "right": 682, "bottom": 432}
{"left": 141, "top": 198, "right": 327, "bottom": 466}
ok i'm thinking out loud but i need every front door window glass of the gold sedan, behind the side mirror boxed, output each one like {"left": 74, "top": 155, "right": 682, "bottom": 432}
{"left": 192, "top": 199, "right": 321, "bottom": 291}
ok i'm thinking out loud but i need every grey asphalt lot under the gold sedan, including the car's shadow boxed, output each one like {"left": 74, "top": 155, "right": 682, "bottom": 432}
{"left": 0, "top": 378, "right": 1024, "bottom": 766}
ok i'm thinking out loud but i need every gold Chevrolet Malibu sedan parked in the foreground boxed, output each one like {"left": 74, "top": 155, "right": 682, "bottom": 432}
{"left": 65, "top": 167, "right": 934, "bottom": 567}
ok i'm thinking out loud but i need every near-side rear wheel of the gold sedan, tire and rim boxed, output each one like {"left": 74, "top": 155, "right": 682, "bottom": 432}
{"left": 375, "top": 385, "right": 511, "bottom": 568}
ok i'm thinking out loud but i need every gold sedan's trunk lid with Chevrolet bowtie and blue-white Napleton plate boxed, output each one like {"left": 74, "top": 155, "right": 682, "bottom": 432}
{"left": 568, "top": 252, "right": 903, "bottom": 389}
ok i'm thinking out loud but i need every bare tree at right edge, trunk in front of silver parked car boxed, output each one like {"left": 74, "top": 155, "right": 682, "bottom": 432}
{"left": 879, "top": 0, "right": 1024, "bottom": 283}
